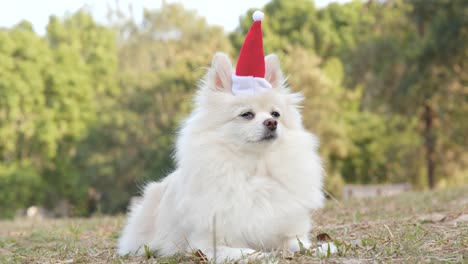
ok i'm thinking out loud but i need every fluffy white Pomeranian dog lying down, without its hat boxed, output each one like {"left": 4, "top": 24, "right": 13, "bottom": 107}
{"left": 118, "top": 53, "right": 324, "bottom": 262}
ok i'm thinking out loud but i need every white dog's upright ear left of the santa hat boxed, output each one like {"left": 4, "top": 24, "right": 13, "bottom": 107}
{"left": 210, "top": 52, "right": 232, "bottom": 92}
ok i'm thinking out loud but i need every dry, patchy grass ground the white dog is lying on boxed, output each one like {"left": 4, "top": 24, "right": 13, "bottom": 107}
{"left": 0, "top": 186, "right": 468, "bottom": 263}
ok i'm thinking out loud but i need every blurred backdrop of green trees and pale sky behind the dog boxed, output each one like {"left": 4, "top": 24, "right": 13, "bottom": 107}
{"left": 0, "top": 0, "right": 468, "bottom": 218}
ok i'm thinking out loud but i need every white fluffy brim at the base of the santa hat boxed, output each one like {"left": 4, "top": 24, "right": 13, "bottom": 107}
{"left": 232, "top": 74, "right": 272, "bottom": 95}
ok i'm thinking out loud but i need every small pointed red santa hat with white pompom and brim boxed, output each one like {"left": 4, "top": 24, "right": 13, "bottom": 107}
{"left": 232, "top": 11, "right": 271, "bottom": 95}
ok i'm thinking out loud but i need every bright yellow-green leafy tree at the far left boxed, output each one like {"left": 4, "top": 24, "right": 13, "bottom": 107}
{"left": 0, "top": 11, "right": 117, "bottom": 217}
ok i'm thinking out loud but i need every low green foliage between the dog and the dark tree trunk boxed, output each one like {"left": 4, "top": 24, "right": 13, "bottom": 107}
{"left": 337, "top": 111, "right": 422, "bottom": 184}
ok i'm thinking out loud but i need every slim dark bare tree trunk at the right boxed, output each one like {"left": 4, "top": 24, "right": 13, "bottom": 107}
{"left": 423, "top": 103, "right": 435, "bottom": 189}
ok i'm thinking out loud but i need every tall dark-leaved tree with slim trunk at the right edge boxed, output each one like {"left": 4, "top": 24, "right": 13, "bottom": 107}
{"left": 349, "top": 0, "right": 467, "bottom": 188}
